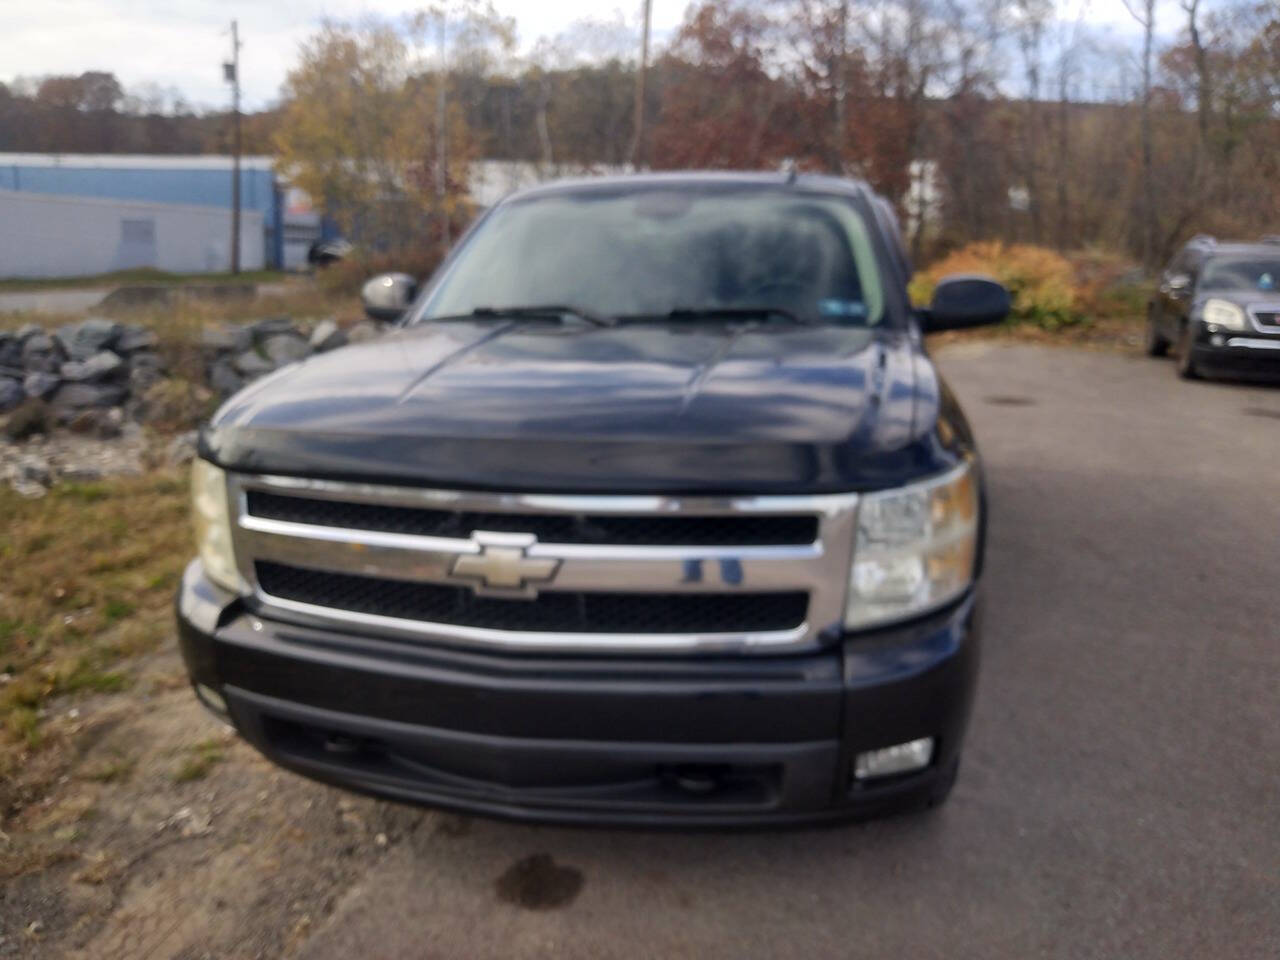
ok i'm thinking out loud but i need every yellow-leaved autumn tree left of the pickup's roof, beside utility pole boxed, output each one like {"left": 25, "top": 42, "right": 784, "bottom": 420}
{"left": 275, "top": 4, "right": 504, "bottom": 250}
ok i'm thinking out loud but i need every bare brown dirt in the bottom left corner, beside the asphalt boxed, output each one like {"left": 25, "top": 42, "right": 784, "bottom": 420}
{"left": 0, "top": 645, "right": 433, "bottom": 960}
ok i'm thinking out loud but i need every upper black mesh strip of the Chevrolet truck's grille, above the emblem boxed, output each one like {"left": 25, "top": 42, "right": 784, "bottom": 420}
{"left": 247, "top": 490, "right": 818, "bottom": 547}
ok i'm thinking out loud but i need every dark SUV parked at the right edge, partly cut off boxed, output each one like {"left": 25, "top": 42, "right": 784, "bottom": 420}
{"left": 1147, "top": 237, "right": 1280, "bottom": 379}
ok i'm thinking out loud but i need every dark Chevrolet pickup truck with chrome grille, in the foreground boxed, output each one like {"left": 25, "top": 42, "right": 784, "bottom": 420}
{"left": 177, "top": 174, "right": 1009, "bottom": 826}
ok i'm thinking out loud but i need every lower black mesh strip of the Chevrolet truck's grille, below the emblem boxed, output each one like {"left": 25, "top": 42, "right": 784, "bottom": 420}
{"left": 256, "top": 561, "right": 808, "bottom": 634}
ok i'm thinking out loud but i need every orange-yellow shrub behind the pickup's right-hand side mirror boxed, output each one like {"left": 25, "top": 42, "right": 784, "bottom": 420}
{"left": 911, "top": 241, "right": 1084, "bottom": 330}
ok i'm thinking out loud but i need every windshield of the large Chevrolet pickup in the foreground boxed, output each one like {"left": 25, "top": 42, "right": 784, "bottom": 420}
{"left": 422, "top": 188, "right": 884, "bottom": 326}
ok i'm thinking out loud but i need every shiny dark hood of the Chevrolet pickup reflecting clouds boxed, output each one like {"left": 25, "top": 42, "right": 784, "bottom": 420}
{"left": 202, "top": 320, "right": 938, "bottom": 492}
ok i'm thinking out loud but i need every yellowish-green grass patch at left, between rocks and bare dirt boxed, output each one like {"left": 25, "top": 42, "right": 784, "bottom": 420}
{"left": 0, "top": 472, "right": 192, "bottom": 768}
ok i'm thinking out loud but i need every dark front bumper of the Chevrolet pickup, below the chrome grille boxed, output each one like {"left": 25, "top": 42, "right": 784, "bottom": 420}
{"left": 177, "top": 561, "right": 978, "bottom": 827}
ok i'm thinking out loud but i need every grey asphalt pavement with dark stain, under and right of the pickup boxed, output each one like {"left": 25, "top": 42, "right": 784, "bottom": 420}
{"left": 293, "top": 343, "right": 1280, "bottom": 960}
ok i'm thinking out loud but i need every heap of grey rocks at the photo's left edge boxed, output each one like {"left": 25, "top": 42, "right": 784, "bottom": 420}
{"left": 0, "top": 317, "right": 164, "bottom": 424}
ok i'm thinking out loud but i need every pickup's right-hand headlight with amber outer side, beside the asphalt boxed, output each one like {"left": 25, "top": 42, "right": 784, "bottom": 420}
{"left": 845, "top": 463, "right": 978, "bottom": 628}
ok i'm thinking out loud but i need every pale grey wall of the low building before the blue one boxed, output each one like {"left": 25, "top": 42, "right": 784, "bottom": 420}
{"left": 0, "top": 189, "right": 265, "bottom": 276}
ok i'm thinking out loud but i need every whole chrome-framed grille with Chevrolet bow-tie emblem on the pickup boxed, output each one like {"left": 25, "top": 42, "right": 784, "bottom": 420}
{"left": 229, "top": 474, "right": 856, "bottom": 653}
